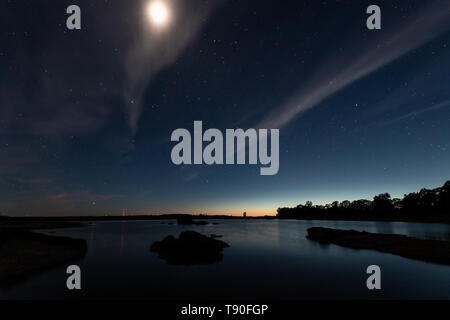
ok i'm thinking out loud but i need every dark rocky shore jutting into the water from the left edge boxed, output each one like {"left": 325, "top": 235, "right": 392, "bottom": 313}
{"left": 0, "top": 228, "right": 87, "bottom": 286}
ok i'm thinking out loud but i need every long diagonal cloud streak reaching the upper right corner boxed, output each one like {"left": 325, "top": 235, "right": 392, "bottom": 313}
{"left": 259, "top": 1, "right": 450, "bottom": 128}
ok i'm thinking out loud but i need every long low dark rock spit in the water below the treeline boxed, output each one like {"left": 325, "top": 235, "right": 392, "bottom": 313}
{"left": 306, "top": 227, "right": 450, "bottom": 265}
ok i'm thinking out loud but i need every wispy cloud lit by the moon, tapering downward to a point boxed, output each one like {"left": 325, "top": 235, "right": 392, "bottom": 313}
{"left": 124, "top": 0, "right": 221, "bottom": 133}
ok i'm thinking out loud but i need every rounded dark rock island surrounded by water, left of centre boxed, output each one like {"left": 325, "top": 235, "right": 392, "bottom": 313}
{"left": 150, "top": 231, "right": 229, "bottom": 265}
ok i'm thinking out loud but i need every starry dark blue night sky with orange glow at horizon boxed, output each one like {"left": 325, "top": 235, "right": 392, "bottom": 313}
{"left": 0, "top": 0, "right": 450, "bottom": 215}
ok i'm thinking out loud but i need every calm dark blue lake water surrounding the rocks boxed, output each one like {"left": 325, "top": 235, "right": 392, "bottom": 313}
{"left": 0, "top": 220, "right": 450, "bottom": 300}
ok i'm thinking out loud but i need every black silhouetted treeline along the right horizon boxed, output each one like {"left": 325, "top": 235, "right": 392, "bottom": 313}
{"left": 277, "top": 181, "right": 450, "bottom": 220}
